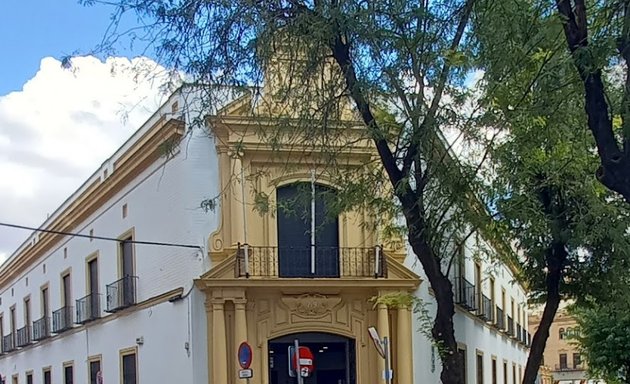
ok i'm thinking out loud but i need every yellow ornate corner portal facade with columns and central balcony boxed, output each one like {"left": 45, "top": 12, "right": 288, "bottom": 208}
{"left": 196, "top": 97, "right": 420, "bottom": 384}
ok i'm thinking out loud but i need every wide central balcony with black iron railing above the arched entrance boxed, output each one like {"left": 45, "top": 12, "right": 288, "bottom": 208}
{"left": 235, "top": 245, "right": 387, "bottom": 278}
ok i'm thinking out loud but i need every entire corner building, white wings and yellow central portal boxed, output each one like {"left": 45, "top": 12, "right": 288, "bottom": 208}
{"left": 0, "top": 88, "right": 529, "bottom": 384}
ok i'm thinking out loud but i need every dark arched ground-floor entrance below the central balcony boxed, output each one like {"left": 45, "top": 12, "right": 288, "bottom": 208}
{"left": 268, "top": 332, "right": 356, "bottom": 384}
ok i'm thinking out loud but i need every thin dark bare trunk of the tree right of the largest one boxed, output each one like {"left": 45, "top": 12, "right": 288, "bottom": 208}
{"left": 523, "top": 250, "right": 566, "bottom": 384}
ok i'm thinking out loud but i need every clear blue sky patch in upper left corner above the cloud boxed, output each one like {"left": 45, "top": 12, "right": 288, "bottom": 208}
{"left": 0, "top": 0, "right": 144, "bottom": 95}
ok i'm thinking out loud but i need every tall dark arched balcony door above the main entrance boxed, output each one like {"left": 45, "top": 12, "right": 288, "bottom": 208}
{"left": 276, "top": 183, "right": 339, "bottom": 277}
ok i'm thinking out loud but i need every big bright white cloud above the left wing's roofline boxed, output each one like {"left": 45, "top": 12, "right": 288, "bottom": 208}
{"left": 0, "top": 57, "right": 174, "bottom": 262}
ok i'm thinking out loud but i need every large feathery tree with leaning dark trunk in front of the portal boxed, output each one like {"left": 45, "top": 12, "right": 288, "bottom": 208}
{"left": 83, "top": 0, "right": 494, "bottom": 384}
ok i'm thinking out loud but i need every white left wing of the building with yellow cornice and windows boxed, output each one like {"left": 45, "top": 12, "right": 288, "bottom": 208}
{"left": 0, "top": 91, "right": 218, "bottom": 383}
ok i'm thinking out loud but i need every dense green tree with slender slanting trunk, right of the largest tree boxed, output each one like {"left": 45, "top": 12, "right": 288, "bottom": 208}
{"left": 475, "top": 1, "right": 628, "bottom": 384}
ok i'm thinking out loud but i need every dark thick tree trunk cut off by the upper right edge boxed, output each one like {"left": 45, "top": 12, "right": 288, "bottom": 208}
{"left": 555, "top": 0, "right": 630, "bottom": 203}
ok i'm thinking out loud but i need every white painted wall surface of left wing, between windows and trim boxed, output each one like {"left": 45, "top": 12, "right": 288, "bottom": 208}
{"left": 0, "top": 91, "right": 225, "bottom": 383}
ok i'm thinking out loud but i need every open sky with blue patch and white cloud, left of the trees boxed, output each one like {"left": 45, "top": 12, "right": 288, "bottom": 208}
{"left": 0, "top": 0, "right": 165, "bottom": 262}
